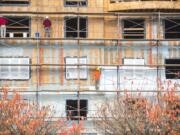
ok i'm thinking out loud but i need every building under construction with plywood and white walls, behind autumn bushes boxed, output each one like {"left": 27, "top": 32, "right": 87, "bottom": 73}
{"left": 0, "top": 0, "right": 180, "bottom": 135}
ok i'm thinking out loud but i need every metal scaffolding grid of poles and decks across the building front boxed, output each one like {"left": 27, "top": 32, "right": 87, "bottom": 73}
{"left": 0, "top": 5, "right": 180, "bottom": 120}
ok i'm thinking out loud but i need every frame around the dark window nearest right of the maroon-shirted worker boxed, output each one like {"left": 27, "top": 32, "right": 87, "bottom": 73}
{"left": 64, "top": 16, "right": 88, "bottom": 39}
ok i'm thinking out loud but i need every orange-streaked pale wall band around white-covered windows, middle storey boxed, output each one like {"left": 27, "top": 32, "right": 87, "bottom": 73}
{"left": 0, "top": 42, "right": 180, "bottom": 90}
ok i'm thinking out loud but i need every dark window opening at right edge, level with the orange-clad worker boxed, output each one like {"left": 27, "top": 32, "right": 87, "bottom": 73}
{"left": 165, "top": 59, "right": 180, "bottom": 79}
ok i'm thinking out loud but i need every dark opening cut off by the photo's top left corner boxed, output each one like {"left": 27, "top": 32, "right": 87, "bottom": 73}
{"left": 0, "top": 0, "right": 30, "bottom": 5}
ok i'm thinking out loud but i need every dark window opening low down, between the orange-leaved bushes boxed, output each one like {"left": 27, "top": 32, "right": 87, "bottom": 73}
{"left": 66, "top": 100, "right": 88, "bottom": 120}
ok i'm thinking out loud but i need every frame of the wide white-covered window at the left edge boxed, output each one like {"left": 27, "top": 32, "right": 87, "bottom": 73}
{"left": 0, "top": 57, "right": 32, "bottom": 81}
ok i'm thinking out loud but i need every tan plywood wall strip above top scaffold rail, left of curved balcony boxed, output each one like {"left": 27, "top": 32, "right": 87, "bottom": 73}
{"left": 1, "top": 0, "right": 104, "bottom": 13}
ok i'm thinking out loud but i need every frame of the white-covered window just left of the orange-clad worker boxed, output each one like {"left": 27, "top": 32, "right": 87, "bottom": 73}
{"left": 64, "top": 56, "right": 88, "bottom": 80}
